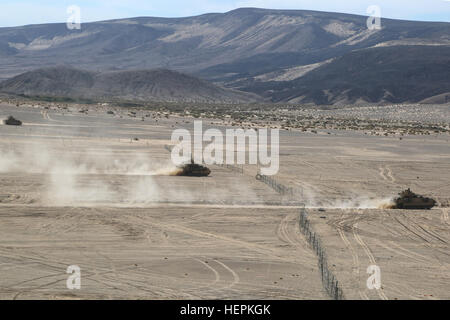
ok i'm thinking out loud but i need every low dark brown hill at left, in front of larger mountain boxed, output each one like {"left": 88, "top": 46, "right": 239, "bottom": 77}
{"left": 0, "top": 66, "right": 261, "bottom": 103}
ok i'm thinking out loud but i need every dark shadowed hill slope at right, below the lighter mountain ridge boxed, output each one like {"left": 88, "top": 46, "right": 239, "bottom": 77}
{"left": 242, "top": 46, "right": 450, "bottom": 105}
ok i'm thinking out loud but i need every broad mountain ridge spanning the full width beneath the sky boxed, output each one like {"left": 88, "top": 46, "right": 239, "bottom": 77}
{"left": 0, "top": 8, "right": 450, "bottom": 104}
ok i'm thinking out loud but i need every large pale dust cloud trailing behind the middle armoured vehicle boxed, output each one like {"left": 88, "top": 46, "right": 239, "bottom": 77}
{"left": 0, "top": 143, "right": 184, "bottom": 206}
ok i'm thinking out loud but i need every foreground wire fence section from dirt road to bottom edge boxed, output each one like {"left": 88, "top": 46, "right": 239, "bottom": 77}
{"left": 300, "top": 208, "right": 345, "bottom": 300}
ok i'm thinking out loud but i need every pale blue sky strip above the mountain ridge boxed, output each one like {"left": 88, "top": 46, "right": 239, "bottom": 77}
{"left": 0, "top": 0, "right": 450, "bottom": 27}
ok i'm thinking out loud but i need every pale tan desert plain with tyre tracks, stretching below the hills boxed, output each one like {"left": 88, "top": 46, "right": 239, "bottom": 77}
{"left": 0, "top": 102, "right": 450, "bottom": 299}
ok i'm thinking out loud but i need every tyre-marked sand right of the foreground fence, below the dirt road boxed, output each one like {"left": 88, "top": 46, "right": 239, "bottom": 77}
{"left": 310, "top": 209, "right": 450, "bottom": 300}
